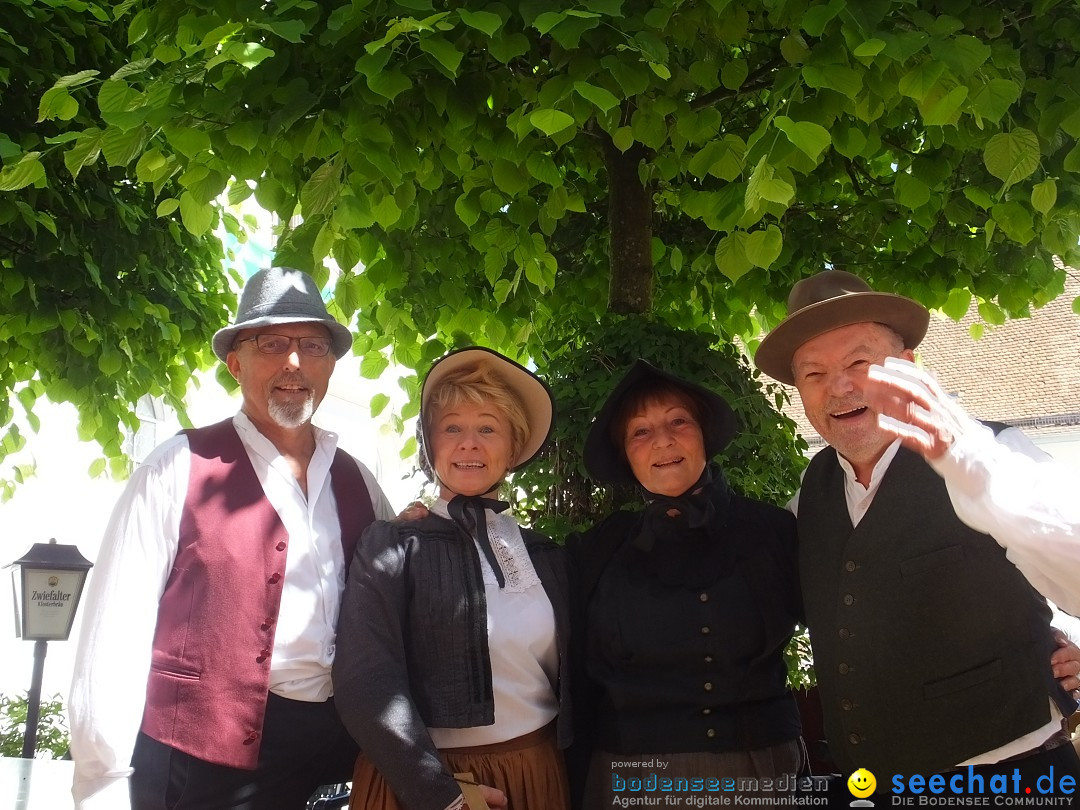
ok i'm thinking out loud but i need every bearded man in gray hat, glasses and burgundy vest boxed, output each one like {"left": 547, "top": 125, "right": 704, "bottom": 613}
{"left": 69, "top": 268, "right": 393, "bottom": 810}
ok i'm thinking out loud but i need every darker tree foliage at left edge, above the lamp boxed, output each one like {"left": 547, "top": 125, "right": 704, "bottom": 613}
{"left": 0, "top": 0, "right": 232, "bottom": 495}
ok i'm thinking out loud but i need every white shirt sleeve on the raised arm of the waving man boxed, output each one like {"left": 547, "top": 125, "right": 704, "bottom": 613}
{"left": 930, "top": 419, "right": 1080, "bottom": 615}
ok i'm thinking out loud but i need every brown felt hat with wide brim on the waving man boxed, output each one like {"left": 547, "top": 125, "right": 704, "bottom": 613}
{"left": 754, "top": 270, "right": 930, "bottom": 386}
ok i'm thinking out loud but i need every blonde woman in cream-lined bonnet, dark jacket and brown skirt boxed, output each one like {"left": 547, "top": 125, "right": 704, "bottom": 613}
{"left": 334, "top": 348, "right": 570, "bottom": 810}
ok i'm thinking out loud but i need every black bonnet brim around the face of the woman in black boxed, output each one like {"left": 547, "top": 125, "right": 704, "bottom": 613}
{"left": 583, "top": 360, "right": 738, "bottom": 484}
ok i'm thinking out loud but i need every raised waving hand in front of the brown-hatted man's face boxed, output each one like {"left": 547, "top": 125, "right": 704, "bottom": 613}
{"left": 864, "top": 357, "right": 971, "bottom": 459}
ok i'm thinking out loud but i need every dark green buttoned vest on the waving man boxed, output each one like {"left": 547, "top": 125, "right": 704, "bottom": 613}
{"left": 798, "top": 448, "right": 1068, "bottom": 773}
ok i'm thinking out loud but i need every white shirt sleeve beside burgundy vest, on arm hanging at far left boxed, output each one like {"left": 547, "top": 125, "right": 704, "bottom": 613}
{"left": 68, "top": 436, "right": 190, "bottom": 810}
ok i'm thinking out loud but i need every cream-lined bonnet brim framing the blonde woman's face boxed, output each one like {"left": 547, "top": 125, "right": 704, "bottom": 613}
{"left": 420, "top": 346, "right": 555, "bottom": 472}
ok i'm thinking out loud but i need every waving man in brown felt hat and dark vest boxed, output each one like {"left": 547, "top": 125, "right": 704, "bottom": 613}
{"left": 755, "top": 270, "right": 1080, "bottom": 795}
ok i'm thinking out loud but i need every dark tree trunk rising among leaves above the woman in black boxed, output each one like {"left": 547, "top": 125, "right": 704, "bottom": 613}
{"left": 604, "top": 135, "right": 652, "bottom": 315}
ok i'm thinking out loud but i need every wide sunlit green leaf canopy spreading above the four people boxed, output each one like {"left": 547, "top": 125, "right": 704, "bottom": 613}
{"left": 0, "top": 0, "right": 1080, "bottom": 505}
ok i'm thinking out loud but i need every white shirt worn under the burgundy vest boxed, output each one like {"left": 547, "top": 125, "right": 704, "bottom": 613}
{"left": 68, "top": 413, "right": 394, "bottom": 810}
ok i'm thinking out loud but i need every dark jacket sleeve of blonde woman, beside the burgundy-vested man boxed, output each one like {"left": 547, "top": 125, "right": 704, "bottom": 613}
{"left": 333, "top": 523, "right": 462, "bottom": 808}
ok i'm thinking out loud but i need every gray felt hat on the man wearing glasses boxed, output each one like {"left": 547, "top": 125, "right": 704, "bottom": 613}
{"left": 213, "top": 267, "right": 352, "bottom": 363}
